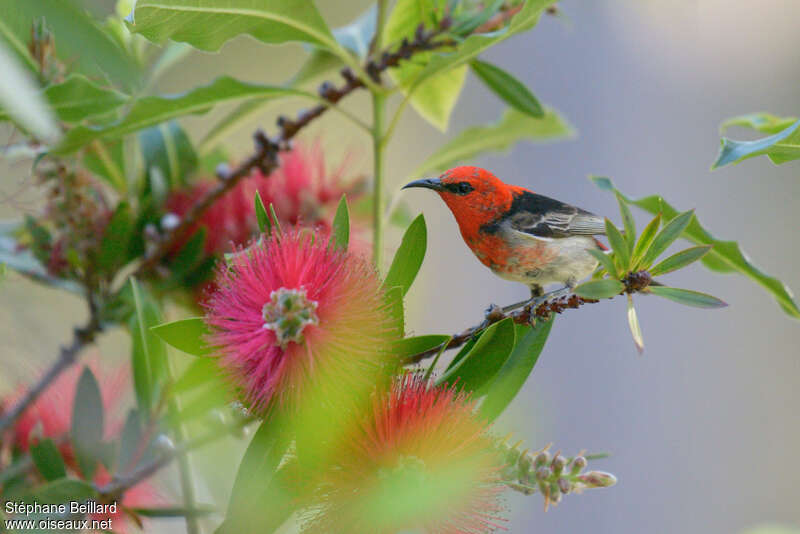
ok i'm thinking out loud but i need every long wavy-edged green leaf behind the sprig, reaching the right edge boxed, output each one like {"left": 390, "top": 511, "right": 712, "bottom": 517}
{"left": 592, "top": 178, "right": 800, "bottom": 319}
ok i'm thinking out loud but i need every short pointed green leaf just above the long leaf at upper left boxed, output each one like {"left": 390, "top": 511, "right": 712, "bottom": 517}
{"left": 0, "top": 74, "right": 128, "bottom": 123}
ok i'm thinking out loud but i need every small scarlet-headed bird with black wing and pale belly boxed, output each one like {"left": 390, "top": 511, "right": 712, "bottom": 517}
{"left": 403, "top": 166, "right": 606, "bottom": 313}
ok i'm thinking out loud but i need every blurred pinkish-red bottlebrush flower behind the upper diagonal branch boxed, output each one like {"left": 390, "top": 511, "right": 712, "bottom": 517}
{"left": 165, "top": 142, "right": 363, "bottom": 255}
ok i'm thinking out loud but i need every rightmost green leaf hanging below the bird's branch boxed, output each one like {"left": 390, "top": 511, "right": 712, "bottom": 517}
{"left": 479, "top": 316, "right": 555, "bottom": 421}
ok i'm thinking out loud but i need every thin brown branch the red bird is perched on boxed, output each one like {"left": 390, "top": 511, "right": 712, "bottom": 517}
{"left": 403, "top": 271, "right": 653, "bottom": 365}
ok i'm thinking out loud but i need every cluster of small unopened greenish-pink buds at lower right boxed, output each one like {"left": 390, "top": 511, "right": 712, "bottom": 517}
{"left": 498, "top": 442, "right": 617, "bottom": 507}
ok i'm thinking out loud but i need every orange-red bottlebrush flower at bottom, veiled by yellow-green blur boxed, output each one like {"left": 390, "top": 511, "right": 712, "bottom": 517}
{"left": 305, "top": 375, "right": 503, "bottom": 534}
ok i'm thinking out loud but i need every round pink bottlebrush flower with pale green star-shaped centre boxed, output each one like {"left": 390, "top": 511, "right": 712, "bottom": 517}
{"left": 205, "top": 231, "right": 400, "bottom": 412}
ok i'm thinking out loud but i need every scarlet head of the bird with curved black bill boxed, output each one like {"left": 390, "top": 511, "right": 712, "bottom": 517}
{"left": 403, "top": 167, "right": 520, "bottom": 234}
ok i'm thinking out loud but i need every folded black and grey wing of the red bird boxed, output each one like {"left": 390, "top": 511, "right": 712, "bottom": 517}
{"left": 507, "top": 191, "right": 606, "bottom": 237}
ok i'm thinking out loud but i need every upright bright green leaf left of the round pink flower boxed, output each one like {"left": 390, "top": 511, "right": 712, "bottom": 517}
{"left": 129, "top": 278, "right": 167, "bottom": 418}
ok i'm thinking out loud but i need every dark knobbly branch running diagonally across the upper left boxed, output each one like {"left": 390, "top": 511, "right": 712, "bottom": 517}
{"left": 135, "top": 23, "right": 454, "bottom": 274}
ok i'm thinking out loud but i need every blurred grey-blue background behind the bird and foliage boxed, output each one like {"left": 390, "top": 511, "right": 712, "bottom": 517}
{"left": 0, "top": 0, "right": 800, "bottom": 534}
